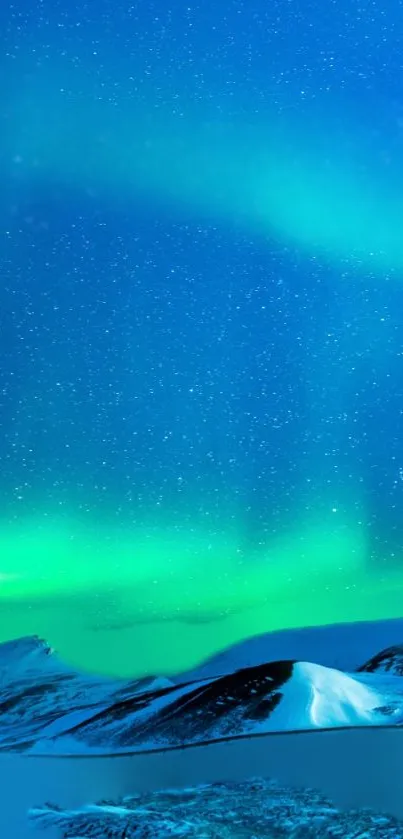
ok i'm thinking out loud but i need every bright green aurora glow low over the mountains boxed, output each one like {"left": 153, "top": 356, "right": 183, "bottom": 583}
{"left": 0, "top": 511, "right": 403, "bottom": 675}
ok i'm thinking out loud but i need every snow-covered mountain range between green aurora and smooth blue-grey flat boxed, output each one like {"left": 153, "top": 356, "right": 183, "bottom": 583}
{"left": 0, "top": 621, "right": 403, "bottom": 755}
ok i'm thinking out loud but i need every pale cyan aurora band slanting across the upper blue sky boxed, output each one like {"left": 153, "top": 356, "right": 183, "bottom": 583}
{"left": 7, "top": 66, "right": 403, "bottom": 273}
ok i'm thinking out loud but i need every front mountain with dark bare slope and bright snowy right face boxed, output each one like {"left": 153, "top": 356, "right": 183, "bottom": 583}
{"left": 30, "top": 661, "right": 403, "bottom": 755}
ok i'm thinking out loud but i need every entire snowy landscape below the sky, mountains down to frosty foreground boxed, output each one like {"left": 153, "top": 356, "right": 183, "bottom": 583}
{"left": 0, "top": 620, "right": 403, "bottom": 839}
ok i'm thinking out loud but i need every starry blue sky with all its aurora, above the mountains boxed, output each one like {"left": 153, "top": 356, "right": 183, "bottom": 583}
{"left": 0, "top": 0, "right": 403, "bottom": 675}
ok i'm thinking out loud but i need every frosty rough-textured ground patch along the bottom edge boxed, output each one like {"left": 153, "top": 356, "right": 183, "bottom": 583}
{"left": 30, "top": 780, "right": 403, "bottom": 839}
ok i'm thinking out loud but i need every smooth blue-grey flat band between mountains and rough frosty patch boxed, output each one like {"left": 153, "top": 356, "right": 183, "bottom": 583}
{"left": 0, "top": 727, "right": 403, "bottom": 839}
